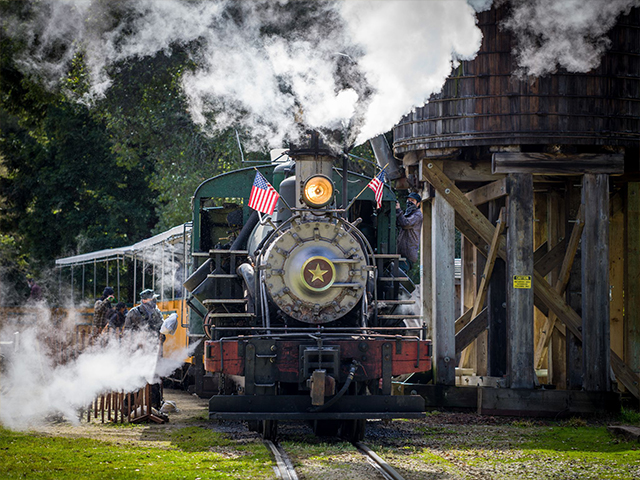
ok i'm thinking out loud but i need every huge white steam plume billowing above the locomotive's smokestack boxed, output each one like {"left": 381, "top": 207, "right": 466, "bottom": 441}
{"left": 5, "top": 0, "right": 481, "bottom": 147}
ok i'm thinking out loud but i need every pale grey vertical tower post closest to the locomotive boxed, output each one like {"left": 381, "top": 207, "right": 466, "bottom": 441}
{"left": 431, "top": 192, "right": 456, "bottom": 385}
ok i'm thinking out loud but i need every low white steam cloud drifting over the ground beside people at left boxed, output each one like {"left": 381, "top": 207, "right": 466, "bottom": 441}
{"left": 0, "top": 305, "right": 194, "bottom": 430}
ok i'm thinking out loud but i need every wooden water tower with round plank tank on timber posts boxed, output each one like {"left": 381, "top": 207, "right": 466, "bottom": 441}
{"left": 393, "top": 5, "right": 640, "bottom": 414}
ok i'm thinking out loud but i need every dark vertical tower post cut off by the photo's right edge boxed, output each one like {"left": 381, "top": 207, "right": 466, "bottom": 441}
{"left": 624, "top": 182, "right": 640, "bottom": 382}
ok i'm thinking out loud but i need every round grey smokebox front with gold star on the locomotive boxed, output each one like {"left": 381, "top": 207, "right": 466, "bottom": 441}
{"left": 264, "top": 220, "right": 367, "bottom": 324}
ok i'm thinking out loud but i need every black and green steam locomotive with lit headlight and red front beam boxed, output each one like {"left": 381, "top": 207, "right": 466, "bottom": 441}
{"left": 185, "top": 134, "right": 431, "bottom": 441}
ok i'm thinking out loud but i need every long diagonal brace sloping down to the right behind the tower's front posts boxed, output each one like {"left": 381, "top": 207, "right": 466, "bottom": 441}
{"left": 423, "top": 163, "right": 640, "bottom": 398}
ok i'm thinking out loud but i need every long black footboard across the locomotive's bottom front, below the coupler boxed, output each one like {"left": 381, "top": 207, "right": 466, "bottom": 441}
{"left": 209, "top": 395, "right": 425, "bottom": 420}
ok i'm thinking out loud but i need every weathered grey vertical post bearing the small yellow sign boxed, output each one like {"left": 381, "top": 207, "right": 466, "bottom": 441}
{"left": 507, "top": 173, "right": 535, "bottom": 388}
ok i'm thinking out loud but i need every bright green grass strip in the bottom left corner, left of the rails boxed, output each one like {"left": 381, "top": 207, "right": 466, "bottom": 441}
{"left": 0, "top": 427, "right": 273, "bottom": 479}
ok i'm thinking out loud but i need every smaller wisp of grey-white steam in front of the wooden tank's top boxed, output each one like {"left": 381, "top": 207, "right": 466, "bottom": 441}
{"left": 504, "top": 0, "right": 640, "bottom": 77}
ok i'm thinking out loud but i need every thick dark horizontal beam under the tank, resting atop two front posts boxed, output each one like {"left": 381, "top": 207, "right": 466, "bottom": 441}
{"left": 491, "top": 153, "right": 624, "bottom": 175}
